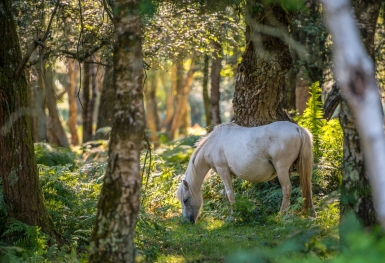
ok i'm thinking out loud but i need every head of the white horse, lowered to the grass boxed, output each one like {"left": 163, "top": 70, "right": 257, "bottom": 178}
{"left": 177, "top": 180, "right": 202, "bottom": 223}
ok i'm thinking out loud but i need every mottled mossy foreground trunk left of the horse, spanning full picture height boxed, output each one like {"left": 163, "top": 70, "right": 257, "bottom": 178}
{"left": 89, "top": 0, "right": 146, "bottom": 263}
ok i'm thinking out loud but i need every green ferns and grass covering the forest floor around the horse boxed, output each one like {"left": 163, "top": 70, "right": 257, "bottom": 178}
{"left": 0, "top": 83, "right": 385, "bottom": 263}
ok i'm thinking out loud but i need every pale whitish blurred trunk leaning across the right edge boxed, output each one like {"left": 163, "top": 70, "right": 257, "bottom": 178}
{"left": 321, "top": 0, "right": 385, "bottom": 228}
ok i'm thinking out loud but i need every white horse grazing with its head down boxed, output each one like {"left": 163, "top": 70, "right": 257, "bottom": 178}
{"left": 176, "top": 121, "right": 315, "bottom": 223}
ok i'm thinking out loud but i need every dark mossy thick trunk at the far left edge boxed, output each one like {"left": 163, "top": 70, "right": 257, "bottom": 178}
{"left": 0, "top": 0, "right": 60, "bottom": 240}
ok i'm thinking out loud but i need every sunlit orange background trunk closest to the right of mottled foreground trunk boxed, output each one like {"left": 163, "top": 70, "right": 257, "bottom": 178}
{"left": 144, "top": 72, "right": 160, "bottom": 146}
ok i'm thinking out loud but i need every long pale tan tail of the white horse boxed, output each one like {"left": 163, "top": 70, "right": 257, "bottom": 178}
{"left": 297, "top": 127, "right": 315, "bottom": 216}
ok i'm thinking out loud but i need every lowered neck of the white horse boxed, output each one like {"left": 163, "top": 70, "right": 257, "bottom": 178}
{"left": 185, "top": 149, "right": 210, "bottom": 196}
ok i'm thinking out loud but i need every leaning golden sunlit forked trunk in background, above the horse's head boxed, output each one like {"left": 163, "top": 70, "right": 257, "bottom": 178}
{"left": 168, "top": 61, "right": 194, "bottom": 140}
